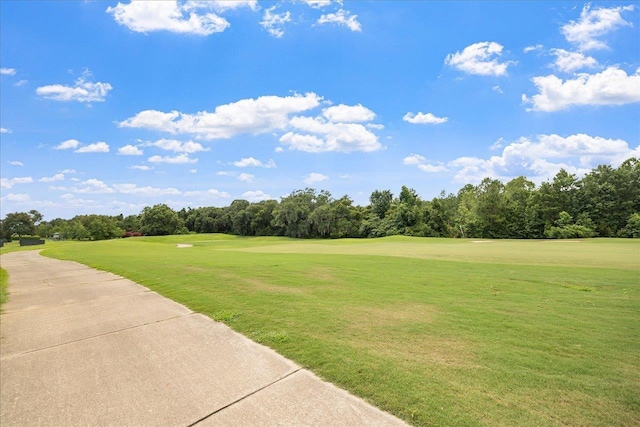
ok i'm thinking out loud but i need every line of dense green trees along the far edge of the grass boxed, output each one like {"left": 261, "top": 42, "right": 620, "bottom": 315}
{"left": 0, "top": 158, "right": 640, "bottom": 240}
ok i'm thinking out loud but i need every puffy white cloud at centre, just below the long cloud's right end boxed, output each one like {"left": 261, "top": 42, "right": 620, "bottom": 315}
{"left": 280, "top": 117, "right": 382, "bottom": 153}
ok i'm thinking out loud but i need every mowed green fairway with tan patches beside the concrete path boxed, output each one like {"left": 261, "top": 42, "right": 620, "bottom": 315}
{"left": 41, "top": 235, "right": 640, "bottom": 426}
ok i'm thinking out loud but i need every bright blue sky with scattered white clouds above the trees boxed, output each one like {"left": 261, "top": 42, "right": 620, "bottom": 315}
{"left": 0, "top": 0, "right": 640, "bottom": 220}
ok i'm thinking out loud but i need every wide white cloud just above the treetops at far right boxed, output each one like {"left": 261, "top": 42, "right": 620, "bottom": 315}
{"left": 448, "top": 134, "right": 640, "bottom": 183}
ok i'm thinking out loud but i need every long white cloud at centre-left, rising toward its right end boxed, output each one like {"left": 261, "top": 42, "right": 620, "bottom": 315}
{"left": 119, "top": 93, "right": 322, "bottom": 139}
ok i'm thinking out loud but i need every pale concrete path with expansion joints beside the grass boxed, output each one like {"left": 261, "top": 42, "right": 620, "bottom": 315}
{"left": 0, "top": 251, "right": 406, "bottom": 427}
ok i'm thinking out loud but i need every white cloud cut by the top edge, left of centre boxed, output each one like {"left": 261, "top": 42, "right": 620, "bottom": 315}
{"left": 107, "top": 0, "right": 230, "bottom": 36}
